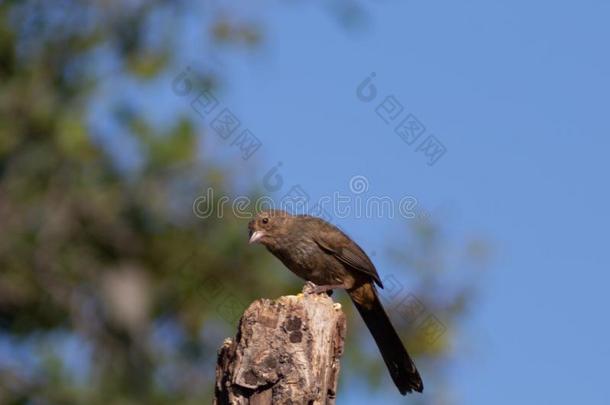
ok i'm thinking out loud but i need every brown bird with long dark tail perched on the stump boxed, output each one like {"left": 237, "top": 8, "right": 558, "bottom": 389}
{"left": 248, "top": 210, "right": 424, "bottom": 395}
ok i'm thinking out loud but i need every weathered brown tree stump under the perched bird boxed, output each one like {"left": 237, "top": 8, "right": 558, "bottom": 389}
{"left": 214, "top": 284, "right": 346, "bottom": 405}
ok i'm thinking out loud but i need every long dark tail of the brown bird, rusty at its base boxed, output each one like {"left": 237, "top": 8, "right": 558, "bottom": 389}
{"left": 348, "top": 283, "right": 424, "bottom": 395}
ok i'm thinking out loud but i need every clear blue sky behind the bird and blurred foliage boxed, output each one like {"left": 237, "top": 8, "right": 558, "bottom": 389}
{"left": 168, "top": 1, "right": 610, "bottom": 405}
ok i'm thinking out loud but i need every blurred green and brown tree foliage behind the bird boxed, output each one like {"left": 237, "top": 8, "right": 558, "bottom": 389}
{"left": 0, "top": 0, "right": 484, "bottom": 404}
